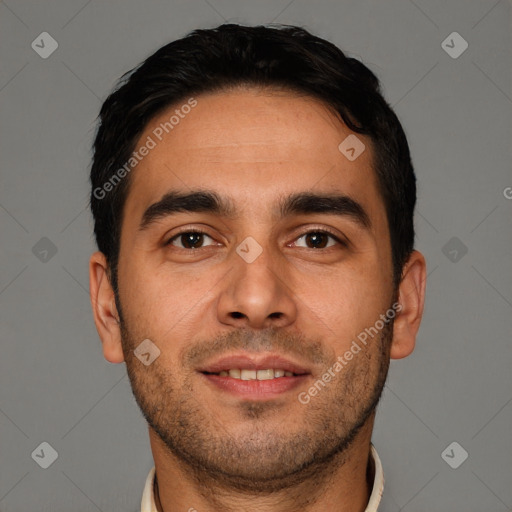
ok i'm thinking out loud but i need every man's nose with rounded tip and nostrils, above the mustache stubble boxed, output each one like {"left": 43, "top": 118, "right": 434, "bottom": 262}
{"left": 218, "top": 243, "right": 297, "bottom": 329}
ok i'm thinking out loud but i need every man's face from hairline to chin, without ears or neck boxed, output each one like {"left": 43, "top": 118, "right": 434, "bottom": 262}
{"left": 110, "top": 90, "right": 395, "bottom": 489}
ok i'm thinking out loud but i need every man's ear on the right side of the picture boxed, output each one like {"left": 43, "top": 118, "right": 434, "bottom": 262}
{"left": 390, "top": 251, "right": 427, "bottom": 359}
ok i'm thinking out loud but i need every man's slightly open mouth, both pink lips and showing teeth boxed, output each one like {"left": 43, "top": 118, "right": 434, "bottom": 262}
{"left": 198, "top": 354, "right": 311, "bottom": 400}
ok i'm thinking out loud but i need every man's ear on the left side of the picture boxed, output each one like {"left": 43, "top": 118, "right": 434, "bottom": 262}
{"left": 89, "top": 251, "right": 124, "bottom": 363}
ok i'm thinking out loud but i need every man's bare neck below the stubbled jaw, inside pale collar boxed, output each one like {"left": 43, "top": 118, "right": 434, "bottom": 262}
{"left": 149, "top": 416, "right": 374, "bottom": 512}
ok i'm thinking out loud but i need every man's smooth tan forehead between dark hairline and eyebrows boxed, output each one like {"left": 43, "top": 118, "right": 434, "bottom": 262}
{"left": 121, "top": 89, "right": 382, "bottom": 224}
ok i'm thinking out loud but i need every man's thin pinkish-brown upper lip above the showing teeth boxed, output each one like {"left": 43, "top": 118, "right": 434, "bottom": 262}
{"left": 198, "top": 353, "right": 311, "bottom": 375}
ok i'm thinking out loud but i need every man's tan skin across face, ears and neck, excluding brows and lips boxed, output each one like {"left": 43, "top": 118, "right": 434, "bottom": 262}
{"left": 90, "top": 89, "right": 426, "bottom": 512}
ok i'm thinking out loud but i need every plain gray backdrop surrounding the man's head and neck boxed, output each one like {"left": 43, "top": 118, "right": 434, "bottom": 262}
{"left": 0, "top": 0, "right": 512, "bottom": 512}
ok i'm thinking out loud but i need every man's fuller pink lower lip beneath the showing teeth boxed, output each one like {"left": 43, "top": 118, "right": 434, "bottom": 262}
{"left": 201, "top": 373, "right": 309, "bottom": 400}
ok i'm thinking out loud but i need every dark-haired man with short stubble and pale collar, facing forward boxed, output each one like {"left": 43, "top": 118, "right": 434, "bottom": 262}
{"left": 90, "top": 25, "right": 425, "bottom": 512}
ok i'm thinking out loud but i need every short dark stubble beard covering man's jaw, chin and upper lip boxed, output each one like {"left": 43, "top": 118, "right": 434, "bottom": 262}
{"left": 121, "top": 314, "right": 393, "bottom": 493}
